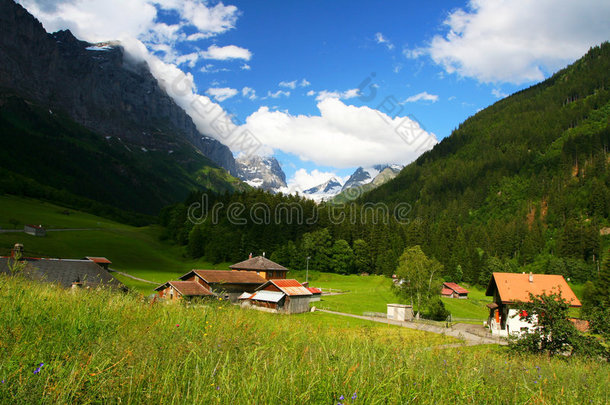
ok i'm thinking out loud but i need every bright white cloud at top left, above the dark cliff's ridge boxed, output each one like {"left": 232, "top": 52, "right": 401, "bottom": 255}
{"left": 20, "top": 0, "right": 247, "bottom": 67}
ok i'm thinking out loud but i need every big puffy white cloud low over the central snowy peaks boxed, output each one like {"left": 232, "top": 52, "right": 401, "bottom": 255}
{"left": 243, "top": 98, "right": 437, "bottom": 168}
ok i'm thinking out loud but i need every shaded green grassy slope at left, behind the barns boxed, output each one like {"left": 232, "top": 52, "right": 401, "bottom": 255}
{"left": 0, "top": 196, "right": 227, "bottom": 295}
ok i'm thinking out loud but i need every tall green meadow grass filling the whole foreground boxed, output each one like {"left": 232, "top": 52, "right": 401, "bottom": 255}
{"left": 0, "top": 276, "right": 610, "bottom": 404}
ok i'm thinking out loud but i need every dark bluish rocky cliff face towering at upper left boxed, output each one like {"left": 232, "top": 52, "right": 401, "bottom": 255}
{"left": 0, "top": 0, "right": 237, "bottom": 175}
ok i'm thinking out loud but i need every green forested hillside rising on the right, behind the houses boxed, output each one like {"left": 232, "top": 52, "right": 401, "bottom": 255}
{"left": 162, "top": 43, "right": 610, "bottom": 285}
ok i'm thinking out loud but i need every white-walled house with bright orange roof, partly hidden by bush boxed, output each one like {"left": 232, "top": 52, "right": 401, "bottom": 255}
{"left": 485, "top": 273, "right": 581, "bottom": 336}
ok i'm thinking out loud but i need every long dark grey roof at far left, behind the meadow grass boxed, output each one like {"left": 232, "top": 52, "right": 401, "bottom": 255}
{"left": 0, "top": 257, "right": 126, "bottom": 289}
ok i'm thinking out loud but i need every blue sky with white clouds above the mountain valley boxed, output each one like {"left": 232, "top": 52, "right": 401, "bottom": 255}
{"left": 21, "top": 0, "right": 610, "bottom": 189}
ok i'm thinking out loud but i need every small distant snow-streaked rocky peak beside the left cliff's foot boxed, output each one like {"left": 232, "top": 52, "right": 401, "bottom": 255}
{"left": 236, "top": 155, "right": 286, "bottom": 192}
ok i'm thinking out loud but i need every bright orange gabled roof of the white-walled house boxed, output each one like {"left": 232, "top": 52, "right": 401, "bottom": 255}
{"left": 485, "top": 273, "right": 581, "bottom": 307}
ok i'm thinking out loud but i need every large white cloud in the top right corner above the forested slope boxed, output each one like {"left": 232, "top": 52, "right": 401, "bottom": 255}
{"left": 416, "top": 0, "right": 610, "bottom": 84}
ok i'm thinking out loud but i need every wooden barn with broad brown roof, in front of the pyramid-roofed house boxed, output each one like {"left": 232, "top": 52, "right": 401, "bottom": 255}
{"left": 173, "top": 270, "right": 266, "bottom": 302}
